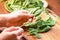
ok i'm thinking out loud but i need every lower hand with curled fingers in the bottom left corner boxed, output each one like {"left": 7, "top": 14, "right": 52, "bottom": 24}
{"left": 0, "top": 27, "right": 24, "bottom": 40}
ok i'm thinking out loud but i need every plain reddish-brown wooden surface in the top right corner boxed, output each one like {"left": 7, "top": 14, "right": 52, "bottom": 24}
{"left": 46, "top": 0, "right": 60, "bottom": 16}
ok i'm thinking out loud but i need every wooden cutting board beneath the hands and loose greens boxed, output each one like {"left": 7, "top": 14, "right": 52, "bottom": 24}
{"left": 0, "top": 2, "right": 60, "bottom": 40}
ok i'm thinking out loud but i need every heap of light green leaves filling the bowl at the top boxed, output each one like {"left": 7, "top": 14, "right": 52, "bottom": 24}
{"left": 6, "top": 0, "right": 44, "bottom": 12}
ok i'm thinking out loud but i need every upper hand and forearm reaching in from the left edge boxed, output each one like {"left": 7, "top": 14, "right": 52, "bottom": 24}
{"left": 0, "top": 10, "right": 33, "bottom": 27}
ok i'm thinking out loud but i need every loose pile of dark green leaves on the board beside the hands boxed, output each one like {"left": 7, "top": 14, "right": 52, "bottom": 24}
{"left": 23, "top": 10, "right": 55, "bottom": 38}
